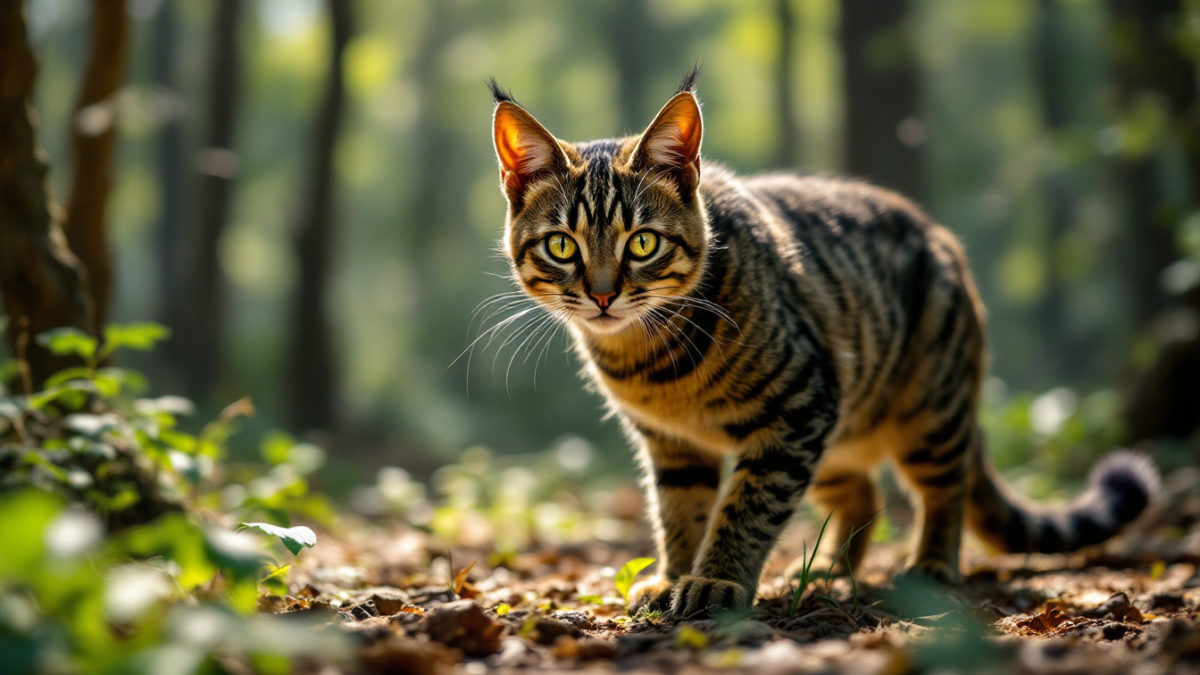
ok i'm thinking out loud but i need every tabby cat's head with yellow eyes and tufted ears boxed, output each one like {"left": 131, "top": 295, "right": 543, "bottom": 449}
{"left": 492, "top": 76, "right": 709, "bottom": 334}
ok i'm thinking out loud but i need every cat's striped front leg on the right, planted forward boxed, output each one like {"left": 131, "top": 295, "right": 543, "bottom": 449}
{"left": 670, "top": 432, "right": 826, "bottom": 619}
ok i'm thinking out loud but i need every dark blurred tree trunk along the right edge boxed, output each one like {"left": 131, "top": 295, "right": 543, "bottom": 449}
{"left": 1110, "top": 0, "right": 1200, "bottom": 441}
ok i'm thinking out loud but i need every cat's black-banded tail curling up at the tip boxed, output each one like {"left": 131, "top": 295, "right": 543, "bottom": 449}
{"left": 967, "top": 441, "right": 1159, "bottom": 554}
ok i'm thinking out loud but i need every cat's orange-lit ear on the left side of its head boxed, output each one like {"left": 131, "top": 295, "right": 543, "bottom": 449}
{"left": 492, "top": 101, "right": 568, "bottom": 207}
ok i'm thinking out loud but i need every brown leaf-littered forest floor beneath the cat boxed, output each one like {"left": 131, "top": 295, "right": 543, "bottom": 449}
{"left": 272, "top": 472, "right": 1200, "bottom": 675}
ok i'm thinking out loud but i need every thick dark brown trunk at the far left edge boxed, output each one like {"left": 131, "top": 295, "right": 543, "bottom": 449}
{"left": 0, "top": 2, "right": 92, "bottom": 389}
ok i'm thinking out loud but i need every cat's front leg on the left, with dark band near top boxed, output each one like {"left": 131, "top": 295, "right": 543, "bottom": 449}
{"left": 630, "top": 431, "right": 721, "bottom": 611}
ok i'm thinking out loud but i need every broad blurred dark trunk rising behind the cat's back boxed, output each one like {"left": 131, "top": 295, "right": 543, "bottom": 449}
{"left": 840, "top": 0, "right": 924, "bottom": 198}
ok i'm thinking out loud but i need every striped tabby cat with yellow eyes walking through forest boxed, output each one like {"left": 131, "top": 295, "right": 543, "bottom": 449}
{"left": 492, "top": 72, "right": 1158, "bottom": 617}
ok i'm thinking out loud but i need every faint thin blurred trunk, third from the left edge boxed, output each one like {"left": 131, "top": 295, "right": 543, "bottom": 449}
{"left": 148, "top": 0, "right": 187, "bottom": 381}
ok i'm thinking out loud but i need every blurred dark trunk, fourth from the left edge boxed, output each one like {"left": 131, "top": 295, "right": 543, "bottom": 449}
{"left": 183, "top": 0, "right": 242, "bottom": 399}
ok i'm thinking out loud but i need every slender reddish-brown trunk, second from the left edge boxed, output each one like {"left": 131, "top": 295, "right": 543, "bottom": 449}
{"left": 62, "top": 0, "right": 130, "bottom": 335}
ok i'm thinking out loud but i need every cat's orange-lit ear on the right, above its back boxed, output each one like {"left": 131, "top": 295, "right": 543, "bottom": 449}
{"left": 630, "top": 91, "right": 704, "bottom": 196}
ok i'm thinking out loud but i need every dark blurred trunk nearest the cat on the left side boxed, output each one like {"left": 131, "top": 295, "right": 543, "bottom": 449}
{"left": 286, "top": 0, "right": 354, "bottom": 431}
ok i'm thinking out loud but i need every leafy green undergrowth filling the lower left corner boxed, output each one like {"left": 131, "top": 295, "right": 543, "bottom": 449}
{"left": 0, "top": 323, "right": 348, "bottom": 673}
